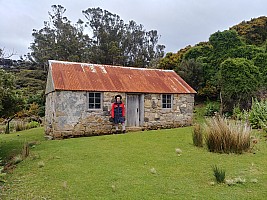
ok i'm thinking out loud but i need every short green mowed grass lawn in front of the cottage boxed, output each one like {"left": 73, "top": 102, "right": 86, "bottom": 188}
{"left": 0, "top": 127, "right": 267, "bottom": 200}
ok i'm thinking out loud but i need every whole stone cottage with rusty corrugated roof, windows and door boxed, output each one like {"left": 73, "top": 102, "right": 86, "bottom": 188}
{"left": 45, "top": 60, "right": 196, "bottom": 138}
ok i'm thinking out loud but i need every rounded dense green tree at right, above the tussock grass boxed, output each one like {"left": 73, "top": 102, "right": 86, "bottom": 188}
{"left": 220, "top": 58, "right": 261, "bottom": 112}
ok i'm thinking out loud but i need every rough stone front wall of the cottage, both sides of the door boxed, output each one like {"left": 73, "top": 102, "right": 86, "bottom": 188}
{"left": 45, "top": 91, "right": 194, "bottom": 138}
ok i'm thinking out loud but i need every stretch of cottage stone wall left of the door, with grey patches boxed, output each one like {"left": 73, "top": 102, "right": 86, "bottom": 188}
{"left": 45, "top": 91, "right": 125, "bottom": 138}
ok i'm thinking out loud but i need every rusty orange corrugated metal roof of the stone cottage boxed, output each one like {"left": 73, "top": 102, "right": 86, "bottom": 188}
{"left": 49, "top": 60, "right": 196, "bottom": 93}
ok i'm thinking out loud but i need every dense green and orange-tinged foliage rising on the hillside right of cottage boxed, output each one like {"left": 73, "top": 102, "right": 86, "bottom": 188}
{"left": 159, "top": 17, "right": 267, "bottom": 112}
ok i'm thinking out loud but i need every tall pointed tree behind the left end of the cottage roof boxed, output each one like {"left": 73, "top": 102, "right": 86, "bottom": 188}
{"left": 29, "top": 5, "right": 90, "bottom": 69}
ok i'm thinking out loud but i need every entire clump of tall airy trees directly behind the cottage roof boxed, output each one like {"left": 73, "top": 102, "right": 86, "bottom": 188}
{"left": 28, "top": 5, "right": 165, "bottom": 67}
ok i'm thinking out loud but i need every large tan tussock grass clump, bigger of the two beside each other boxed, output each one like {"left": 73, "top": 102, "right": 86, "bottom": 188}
{"left": 204, "top": 117, "right": 251, "bottom": 153}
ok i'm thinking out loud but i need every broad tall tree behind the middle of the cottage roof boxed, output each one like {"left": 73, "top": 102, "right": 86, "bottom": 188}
{"left": 83, "top": 7, "right": 165, "bottom": 67}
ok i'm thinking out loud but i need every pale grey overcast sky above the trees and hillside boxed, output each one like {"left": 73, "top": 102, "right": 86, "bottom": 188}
{"left": 0, "top": 0, "right": 267, "bottom": 59}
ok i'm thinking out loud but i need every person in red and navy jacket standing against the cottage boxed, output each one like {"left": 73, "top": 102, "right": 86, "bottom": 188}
{"left": 111, "top": 95, "right": 126, "bottom": 133}
